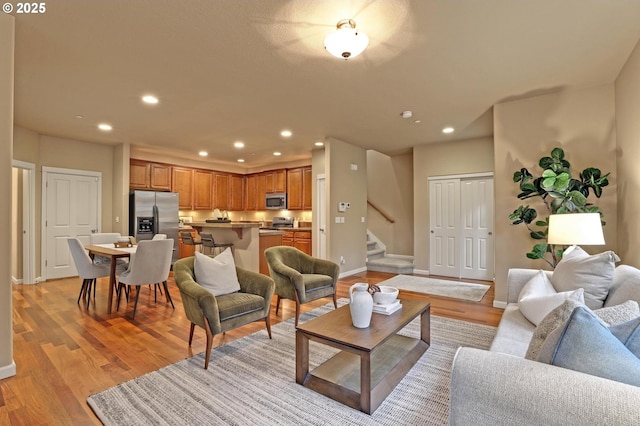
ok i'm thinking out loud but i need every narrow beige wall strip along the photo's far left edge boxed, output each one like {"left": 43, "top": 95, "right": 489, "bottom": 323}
{"left": 0, "top": 14, "right": 16, "bottom": 379}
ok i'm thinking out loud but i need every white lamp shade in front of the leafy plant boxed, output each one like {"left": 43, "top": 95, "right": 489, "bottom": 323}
{"left": 547, "top": 213, "right": 604, "bottom": 246}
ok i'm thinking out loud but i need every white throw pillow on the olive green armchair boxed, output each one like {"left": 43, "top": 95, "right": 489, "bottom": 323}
{"left": 193, "top": 248, "right": 240, "bottom": 296}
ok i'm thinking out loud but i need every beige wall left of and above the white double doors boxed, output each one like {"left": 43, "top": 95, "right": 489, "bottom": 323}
{"left": 413, "top": 138, "right": 493, "bottom": 271}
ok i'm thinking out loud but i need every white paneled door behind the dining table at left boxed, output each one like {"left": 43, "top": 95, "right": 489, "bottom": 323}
{"left": 42, "top": 168, "right": 102, "bottom": 279}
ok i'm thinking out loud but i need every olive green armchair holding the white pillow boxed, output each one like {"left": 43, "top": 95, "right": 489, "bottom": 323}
{"left": 173, "top": 257, "right": 275, "bottom": 370}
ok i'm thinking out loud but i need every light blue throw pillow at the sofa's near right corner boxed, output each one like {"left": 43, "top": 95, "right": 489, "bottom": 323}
{"left": 551, "top": 307, "right": 640, "bottom": 386}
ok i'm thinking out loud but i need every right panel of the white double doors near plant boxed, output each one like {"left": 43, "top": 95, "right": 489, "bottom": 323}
{"left": 460, "top": 178, "right": 494, "bottom": 280}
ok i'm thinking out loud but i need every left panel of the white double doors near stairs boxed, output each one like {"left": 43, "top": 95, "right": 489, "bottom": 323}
{"left": 429, "top": 179, "right": 460, "bottom": 277}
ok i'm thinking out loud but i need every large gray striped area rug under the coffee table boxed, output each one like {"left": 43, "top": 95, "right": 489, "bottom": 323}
{"left": 87, "top": 299, "right": 495, "bottom": 426}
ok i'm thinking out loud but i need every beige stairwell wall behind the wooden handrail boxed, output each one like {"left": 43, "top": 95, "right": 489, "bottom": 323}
{"left": 367, "top": 150, "right": 413, "bottom": 256}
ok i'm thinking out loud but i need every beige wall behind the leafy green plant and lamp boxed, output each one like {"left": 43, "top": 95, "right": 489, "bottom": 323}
{"left": 494, "top": 85, "right": 618, "bottom": 301}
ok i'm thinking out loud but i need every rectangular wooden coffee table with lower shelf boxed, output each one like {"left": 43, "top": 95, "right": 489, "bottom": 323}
{"left": 296, "top": 300, "right": 431, "bottom": 414}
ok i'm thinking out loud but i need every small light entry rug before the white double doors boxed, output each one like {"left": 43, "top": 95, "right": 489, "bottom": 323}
{"left": 378, "top": 275, "right": 489, "bottom": 302}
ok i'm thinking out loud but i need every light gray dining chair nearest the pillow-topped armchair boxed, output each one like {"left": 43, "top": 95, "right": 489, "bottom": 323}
{"left": 116, "top": 239, "right": 175, "bottom": 319}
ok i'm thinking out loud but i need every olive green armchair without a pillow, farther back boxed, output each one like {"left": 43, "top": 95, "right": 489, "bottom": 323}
{"left": 264, "top": 246, "right": 340, "bottom": 326}
